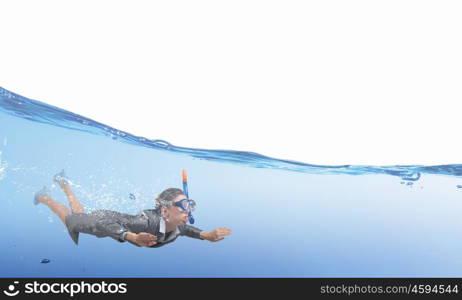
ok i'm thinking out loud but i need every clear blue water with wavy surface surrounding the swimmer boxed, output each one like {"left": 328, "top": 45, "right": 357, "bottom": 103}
{"left": 0, "top": 88, "right": 462, "bottom": 277}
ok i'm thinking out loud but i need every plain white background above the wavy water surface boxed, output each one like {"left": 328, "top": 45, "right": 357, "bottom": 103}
{"left": 0, "top": 0, "right": 462, "bottom": 164}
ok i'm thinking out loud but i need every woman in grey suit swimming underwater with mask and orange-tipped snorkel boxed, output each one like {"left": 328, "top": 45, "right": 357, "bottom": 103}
{"left": 34, "top": 170, "right": 231, "bottom": 247}
